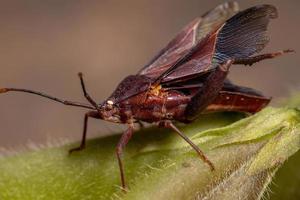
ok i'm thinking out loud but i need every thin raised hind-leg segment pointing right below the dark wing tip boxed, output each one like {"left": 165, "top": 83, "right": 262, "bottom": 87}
{"left": 233, "top": 49, "right": 294, "bottom": 66}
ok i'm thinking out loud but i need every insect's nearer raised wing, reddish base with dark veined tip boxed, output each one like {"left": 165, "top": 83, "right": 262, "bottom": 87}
{"left": 160, "top": 5, "right": 277, "bottom": 83}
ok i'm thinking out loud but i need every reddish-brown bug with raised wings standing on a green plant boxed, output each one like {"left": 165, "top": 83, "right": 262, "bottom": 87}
{"left": 0, "top": 2, "right": 292, "bottom": 189}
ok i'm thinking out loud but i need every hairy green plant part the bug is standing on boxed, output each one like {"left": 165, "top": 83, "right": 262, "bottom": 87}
{"left": 0, "top": 108, "right": 300, "bottom": 200}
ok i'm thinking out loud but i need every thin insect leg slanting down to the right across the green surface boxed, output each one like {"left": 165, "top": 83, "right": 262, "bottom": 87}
{"left": 160, "top": 121, "right": 215, "bottom": 171}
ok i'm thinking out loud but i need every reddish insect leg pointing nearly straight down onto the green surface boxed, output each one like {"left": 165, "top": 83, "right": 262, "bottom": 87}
{"left": 116, "top": 124, "right": 133, "bottom": 191}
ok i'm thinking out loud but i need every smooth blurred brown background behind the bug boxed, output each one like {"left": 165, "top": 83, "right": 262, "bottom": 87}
{"left": 0, "top": 0, "right": 300, "bottom": 148}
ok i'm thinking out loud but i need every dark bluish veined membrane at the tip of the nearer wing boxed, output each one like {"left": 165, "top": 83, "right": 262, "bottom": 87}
{"left": 215, "top": 5, "right": 278, "bottom": 62}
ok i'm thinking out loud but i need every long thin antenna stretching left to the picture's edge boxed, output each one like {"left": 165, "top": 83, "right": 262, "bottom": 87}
{"left": 0, "top": 88, "right": 95, "bottom": 109}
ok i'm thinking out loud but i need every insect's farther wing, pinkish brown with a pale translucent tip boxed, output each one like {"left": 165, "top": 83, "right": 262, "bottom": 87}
{"left": 138, "top": 2, "right": 238, "bottom": 79}
